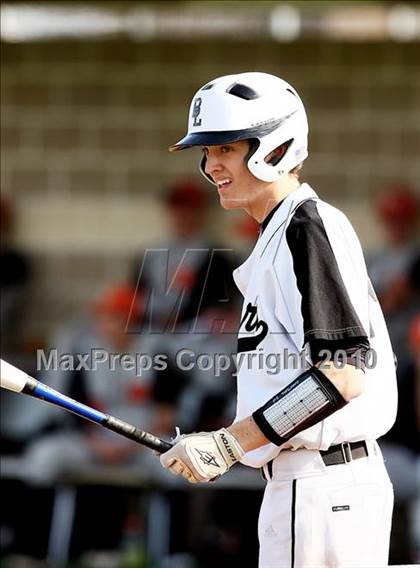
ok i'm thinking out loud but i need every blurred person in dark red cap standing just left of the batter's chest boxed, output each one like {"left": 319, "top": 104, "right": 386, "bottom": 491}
{"left": 136, "top": 181, "right": 239, "bottom": 431}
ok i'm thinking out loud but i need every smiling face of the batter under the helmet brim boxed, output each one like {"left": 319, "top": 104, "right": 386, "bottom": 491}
{"left": 203, "top": 140, "right": 266, "bottom": 214}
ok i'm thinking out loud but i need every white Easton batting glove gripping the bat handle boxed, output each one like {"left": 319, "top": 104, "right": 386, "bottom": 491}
{"left": 160, "top": 428, "right": 245, "bottom": 483}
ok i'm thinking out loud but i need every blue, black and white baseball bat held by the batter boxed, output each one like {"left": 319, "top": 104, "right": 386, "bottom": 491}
{"left": 0, "top": 359, "right": 172, "bottom": 454}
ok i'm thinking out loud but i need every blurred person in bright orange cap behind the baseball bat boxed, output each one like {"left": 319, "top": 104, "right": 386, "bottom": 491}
{"left": 3, "top": 285, "right": 161, "bottom": 485}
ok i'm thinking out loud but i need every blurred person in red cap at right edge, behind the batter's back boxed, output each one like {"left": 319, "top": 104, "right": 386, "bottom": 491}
{"left": 368, "top": 184, "right": 420, "bottom": 563}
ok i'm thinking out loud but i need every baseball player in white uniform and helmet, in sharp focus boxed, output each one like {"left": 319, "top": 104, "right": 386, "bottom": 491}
{"left": 160, "top": 73, "right": 397, "bottom": 568}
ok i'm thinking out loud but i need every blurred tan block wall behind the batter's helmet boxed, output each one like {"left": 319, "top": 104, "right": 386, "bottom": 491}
{"left": 1, "top": 2, "right": 420, "bottom": 342}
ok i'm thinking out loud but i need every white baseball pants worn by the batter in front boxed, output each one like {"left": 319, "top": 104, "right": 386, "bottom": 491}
{"left": 258, "top": 442, "right": 393, "bottom": 568}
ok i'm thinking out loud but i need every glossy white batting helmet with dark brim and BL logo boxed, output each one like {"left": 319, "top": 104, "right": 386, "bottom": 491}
{"left": 169, "top": 73, "right": 308, "bottom": 182}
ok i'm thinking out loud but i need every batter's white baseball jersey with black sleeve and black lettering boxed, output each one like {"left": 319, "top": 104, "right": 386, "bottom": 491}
{"left": 234, "top": 183, "right": 397, "bottom": 467}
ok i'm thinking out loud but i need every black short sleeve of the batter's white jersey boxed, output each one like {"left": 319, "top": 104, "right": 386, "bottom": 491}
{"left": 286, "top": 200, "right": 368, "bottom": 343}
